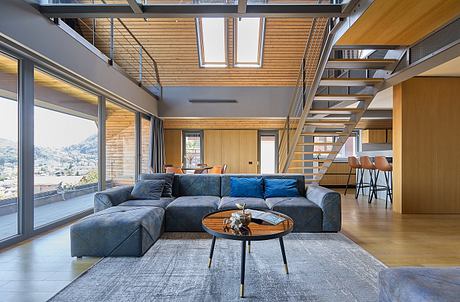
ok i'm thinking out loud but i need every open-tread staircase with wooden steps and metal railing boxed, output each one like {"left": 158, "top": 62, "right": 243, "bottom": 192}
{"left": 279, "top": 21, "right": 401, "bottom": 184}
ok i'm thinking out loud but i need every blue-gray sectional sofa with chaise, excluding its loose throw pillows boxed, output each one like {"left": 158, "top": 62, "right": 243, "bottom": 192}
{"left": 71, "top": 174, "right": 341, "bottom": 257}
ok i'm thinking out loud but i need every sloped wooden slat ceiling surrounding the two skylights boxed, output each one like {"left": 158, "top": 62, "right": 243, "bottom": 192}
{"left": 84, "top": 18, "right": 327, "bottom": 86}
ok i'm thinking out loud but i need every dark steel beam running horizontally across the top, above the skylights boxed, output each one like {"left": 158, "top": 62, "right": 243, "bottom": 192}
{"left": 38, "top": 1, "right": 346, "bottom": 18}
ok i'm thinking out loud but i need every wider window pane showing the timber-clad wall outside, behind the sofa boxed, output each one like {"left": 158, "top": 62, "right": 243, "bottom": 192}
{"left": 105, "top": 101, "right": 136, "bottom": 188}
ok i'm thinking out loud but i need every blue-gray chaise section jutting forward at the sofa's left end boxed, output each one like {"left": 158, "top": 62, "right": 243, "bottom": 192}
{"left": 70, "top": 206, "right": 165, "bottom": 257}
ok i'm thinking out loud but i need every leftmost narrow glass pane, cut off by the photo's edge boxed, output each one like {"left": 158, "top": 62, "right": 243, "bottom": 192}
{"left": 0, "top": 53, "right": 19, "bottom": 240}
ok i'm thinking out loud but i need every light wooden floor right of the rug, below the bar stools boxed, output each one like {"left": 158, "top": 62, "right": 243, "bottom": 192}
{"left": 342, "top": 191, "right": 460, "bottom": 266}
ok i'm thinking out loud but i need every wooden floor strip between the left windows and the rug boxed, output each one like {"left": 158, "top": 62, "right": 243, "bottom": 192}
{"left": 0, "top": 226, "right": 99, "bottom": 302}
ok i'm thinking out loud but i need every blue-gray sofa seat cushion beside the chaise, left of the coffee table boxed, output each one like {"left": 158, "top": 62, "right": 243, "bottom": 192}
{"left": 165, "top": 196, "right": 220, "bottom": 232}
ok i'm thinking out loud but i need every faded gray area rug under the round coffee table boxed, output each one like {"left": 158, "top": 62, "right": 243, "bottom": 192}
{"left": 51, "top": 233, "right": 385, "bottom": 302}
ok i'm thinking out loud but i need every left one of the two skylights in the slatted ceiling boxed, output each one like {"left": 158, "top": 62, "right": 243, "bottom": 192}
{"left": 196, "top": 18, "right": 228, "bottom": 67}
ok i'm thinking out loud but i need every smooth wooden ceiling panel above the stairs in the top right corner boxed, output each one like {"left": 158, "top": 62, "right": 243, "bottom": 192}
{"left": 337, "top": 0, "right": 460, "bottom": 46}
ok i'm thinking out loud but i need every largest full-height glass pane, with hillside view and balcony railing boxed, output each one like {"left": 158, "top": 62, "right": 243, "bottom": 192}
{"left": 34, "top": 69, "right": 98, "bottom": 227}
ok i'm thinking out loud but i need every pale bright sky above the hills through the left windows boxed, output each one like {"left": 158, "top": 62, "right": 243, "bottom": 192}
{"left": 0, "top": 97, "right": 97, "bottom": 148}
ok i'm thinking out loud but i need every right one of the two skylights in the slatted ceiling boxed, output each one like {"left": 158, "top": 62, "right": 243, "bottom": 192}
{"left": 233, "top": 18, "right": 265, "bottom": 67}
